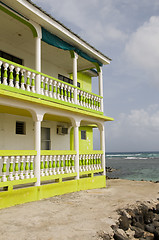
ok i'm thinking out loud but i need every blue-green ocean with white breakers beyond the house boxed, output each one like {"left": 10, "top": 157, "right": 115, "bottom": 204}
{"left": 106, "top": 152, "right": 159, "bottom": 182}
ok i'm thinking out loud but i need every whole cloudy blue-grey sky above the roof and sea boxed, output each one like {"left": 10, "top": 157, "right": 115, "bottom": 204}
{"left": 33, "top": 0, "right": 159, "bottom": 152}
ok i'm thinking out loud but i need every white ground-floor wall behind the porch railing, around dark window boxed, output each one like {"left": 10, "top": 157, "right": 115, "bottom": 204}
{"left": 0, "top": 113, "right": 70, "bottom": 150}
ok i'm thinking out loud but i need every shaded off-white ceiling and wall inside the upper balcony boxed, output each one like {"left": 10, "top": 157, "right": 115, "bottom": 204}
{"left": 0, "top": 7, "right": 98, "bottom": 74}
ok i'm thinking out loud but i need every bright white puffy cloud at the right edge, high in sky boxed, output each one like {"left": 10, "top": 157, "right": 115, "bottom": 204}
{"left": 125, "top": 16, "right": 159, "bottom": 83}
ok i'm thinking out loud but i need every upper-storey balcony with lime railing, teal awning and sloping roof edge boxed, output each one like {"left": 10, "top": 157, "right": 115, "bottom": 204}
{"left": 0, "top": 0, "right": 110, "bottom": 117}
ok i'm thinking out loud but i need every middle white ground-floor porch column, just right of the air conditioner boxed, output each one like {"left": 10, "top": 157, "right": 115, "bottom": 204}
{"left": 74, "top": 121, "right": 80, "bottom": 179}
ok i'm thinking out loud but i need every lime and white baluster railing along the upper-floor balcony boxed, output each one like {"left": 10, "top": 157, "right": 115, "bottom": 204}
{"left": 0, "top": 58, "right": 103, "bottom": 113}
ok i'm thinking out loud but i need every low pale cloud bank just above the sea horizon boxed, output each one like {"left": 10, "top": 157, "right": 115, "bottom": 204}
{"left": 108, "top": 104, "right": 159, "bottom": 151}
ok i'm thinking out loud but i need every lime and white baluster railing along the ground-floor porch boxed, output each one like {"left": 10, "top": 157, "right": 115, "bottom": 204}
{"left": 0, "top": 150, "right": 103, "bottom": 188}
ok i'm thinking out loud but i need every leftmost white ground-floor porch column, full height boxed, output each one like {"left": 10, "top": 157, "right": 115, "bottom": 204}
{"left": 35, "top": 114, "right": 43, "bottom": 186}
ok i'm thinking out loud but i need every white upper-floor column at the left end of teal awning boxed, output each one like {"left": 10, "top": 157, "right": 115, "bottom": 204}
{"left": 35, "top": 37, "right": 41, "bottom": 94}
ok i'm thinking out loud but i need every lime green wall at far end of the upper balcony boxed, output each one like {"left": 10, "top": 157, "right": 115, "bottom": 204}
{"left": 70, "top": 72, "right": 92, "bottom": 92}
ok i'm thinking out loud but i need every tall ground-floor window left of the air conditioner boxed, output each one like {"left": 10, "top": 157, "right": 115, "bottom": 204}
{"left": 41, "top": 127, "right": 51, "bottom": 150}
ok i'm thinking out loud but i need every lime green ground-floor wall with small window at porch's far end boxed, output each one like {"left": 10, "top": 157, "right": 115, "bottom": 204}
{"left": 70, "top": 126, "right": 93, "bottom": 151}
